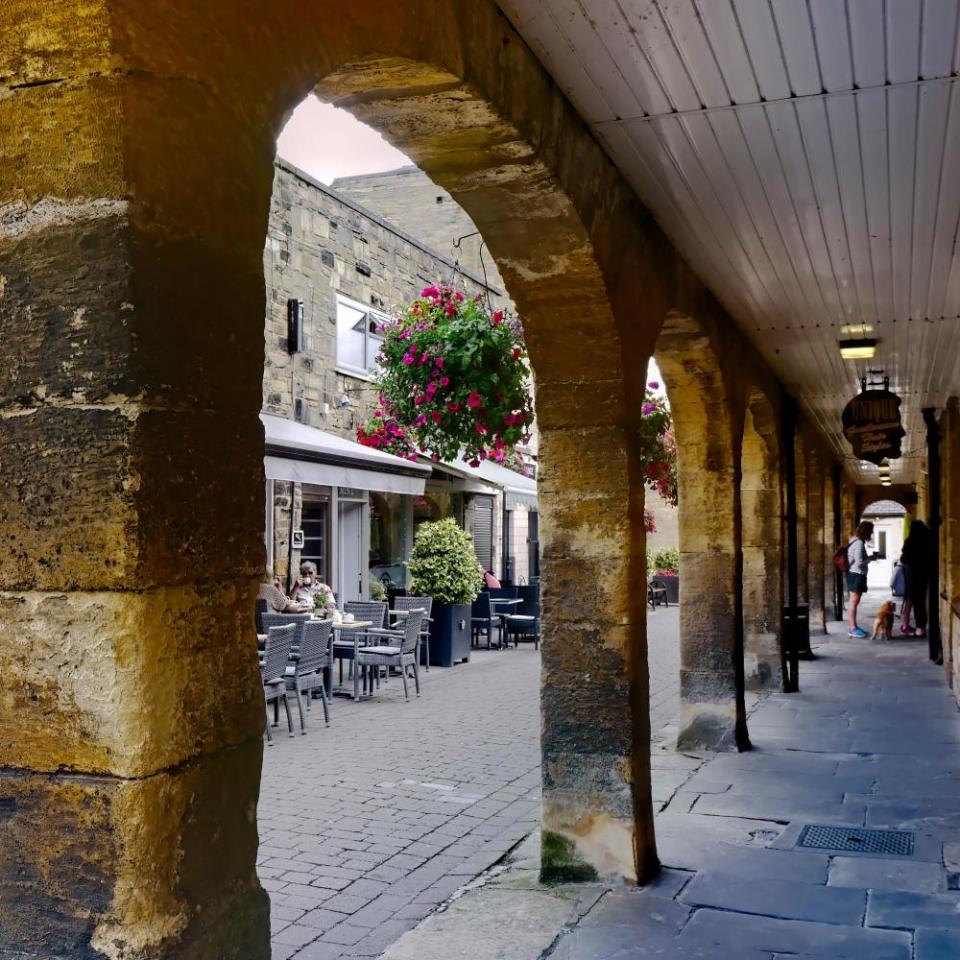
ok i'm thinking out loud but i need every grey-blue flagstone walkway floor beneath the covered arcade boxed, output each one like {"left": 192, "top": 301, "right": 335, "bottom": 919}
{"left": 385, "top": 600, "right": 960, "bottom": 960}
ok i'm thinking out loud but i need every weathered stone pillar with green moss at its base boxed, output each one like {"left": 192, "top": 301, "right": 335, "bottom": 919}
{"left": 534, "top": 374, "right": 658, "bottom": 882}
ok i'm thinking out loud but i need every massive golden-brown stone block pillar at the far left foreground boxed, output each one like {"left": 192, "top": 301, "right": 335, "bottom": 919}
{"left": 0, "top": 20, "right": 270, "bottom": 960}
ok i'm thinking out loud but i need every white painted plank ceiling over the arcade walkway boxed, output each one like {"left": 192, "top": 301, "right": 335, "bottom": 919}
{"left": 499, "top": 0, "right": 960, "bottom": 481}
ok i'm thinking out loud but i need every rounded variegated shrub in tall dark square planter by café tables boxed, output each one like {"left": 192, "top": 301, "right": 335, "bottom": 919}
{"left": 407, "top": 517, "right": 483, "bottom": 667}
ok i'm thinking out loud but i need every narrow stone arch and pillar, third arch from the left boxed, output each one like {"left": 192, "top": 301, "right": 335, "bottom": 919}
{"left": 740, "top": 389, "right": 784, "bottom": 690}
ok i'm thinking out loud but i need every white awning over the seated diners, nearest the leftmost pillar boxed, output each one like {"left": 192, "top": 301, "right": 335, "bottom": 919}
{"left": 260, "top": 413, "right": 431, "bottom": 496}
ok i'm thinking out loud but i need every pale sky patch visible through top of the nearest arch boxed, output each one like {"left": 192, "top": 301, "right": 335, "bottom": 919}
{"left": 277, "top": 95, "right": 410, "bottom": 183}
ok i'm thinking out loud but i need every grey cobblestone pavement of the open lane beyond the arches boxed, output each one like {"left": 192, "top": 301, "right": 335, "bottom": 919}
{"left": 258, "top": 608, "right": 679, "bottom": 960}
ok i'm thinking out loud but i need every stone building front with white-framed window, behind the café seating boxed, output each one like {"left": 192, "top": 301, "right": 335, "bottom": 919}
{"left": 263, "top": 160, "right": 530, "bottom": 599}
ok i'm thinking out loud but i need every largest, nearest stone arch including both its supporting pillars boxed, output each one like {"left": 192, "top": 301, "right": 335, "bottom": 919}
{"left": 0, "top": 0, "right": 752, "bottom": 958}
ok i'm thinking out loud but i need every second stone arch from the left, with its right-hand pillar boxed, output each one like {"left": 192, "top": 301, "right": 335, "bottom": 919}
{"left": 655, "top": 311, "right": 749, "bottom": 749}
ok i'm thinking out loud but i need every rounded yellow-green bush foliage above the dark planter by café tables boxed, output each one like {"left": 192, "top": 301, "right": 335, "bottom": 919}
{"left": 407, "top": 517, "right": 483, "bottom": 603}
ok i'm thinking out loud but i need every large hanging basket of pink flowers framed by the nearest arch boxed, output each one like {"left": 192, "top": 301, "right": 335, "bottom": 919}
{"left": 357, "top": 286, "right": 533, "bottom": 466}
